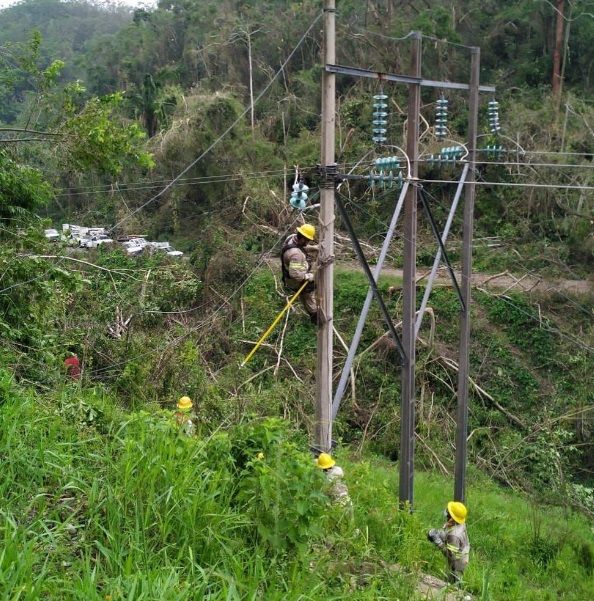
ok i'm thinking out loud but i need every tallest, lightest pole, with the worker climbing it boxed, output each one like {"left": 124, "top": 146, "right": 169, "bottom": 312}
{"left": 315, "top": 0, "right": 336, "bottom": 452}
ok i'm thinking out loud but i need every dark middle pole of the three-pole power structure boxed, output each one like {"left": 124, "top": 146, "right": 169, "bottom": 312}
{"left": 399, "top": 32, "right": 421, "bottom": 507}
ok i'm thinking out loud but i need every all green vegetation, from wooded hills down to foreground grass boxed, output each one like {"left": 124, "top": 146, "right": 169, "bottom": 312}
{"left": 0, "top": 0, "right": 594, "bottom": 601}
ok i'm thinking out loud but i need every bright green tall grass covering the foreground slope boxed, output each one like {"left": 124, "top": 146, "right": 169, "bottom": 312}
{"left": 0, "top": 371, "right": 594, "bottom": 601}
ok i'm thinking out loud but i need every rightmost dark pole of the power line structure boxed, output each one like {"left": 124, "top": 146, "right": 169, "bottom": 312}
{"left": 454, "top": 48, "right": 481, "bottom": 502}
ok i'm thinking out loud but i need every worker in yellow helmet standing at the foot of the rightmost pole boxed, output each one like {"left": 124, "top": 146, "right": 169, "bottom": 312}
{"left": 427, "top": 501, "right": 470, "bottom": 584}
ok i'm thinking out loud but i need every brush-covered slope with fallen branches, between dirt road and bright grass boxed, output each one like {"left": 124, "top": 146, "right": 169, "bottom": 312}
{"left": 0, "top": 230, "right": 594, "bottom": 502}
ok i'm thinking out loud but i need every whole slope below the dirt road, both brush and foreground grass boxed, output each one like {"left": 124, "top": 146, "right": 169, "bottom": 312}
{"left": 0, "top": 232, "right": 594, "bottom": 600}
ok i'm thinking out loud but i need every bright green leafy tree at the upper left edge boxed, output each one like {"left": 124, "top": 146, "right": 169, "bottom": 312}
{"left": 0, "top": 32, "right": 154, "bottom": 217}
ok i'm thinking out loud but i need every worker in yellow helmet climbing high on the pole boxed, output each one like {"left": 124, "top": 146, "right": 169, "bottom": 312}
{"left": 281, "top": 223, "right": 318, "bottom": 324}
